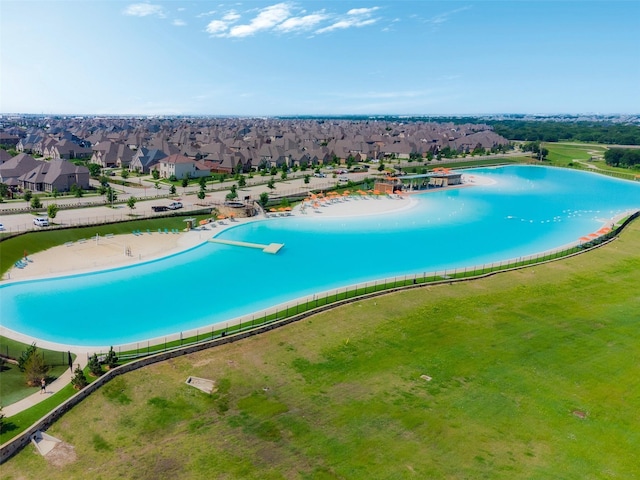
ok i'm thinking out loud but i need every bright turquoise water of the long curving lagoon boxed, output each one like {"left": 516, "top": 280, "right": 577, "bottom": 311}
{"left": 0, "top": 166, "right": 640, "bottom": 346}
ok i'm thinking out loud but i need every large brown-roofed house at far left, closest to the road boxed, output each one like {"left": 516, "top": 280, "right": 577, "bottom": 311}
{"left": 18, "top": 158, "right": 89, "bottom": 192}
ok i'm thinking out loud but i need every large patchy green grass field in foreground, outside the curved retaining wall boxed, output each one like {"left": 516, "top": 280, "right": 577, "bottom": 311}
{"left": 0, "top": 222, "right": 640, "bottom": 480}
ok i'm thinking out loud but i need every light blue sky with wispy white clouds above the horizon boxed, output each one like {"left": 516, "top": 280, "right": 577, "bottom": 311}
{"left": 0, "top": 0, "right": 640, "bottom": 116}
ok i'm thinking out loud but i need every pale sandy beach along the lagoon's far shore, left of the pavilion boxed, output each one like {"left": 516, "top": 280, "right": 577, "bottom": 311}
{"left": 3, "top": 195, "right": 417, "bottom": 282}
